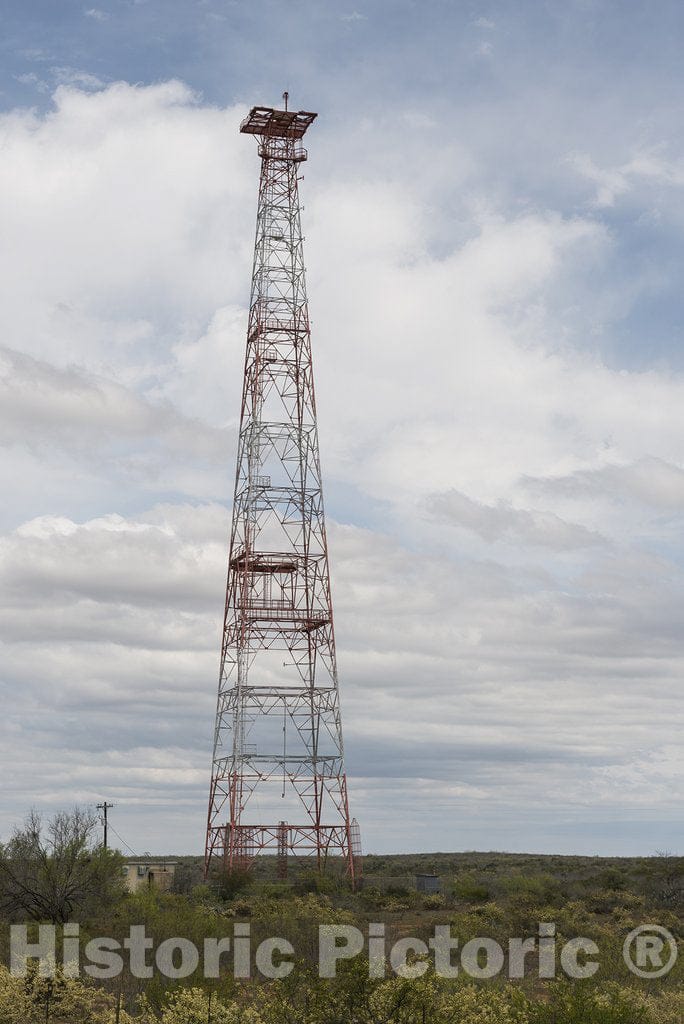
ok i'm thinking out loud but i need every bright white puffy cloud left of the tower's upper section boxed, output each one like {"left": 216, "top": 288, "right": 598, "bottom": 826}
{"left": 0, "top": 82, "right": 253, "bottom": 379}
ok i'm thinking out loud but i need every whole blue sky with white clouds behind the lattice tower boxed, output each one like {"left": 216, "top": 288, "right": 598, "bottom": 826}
{"left": 0, "top": 0, "right": 684, "bottom": 855}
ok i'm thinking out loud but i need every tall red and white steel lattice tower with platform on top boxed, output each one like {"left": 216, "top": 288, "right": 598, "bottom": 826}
{"left": 205, "top": 99, "right": 360, "bottom": 882}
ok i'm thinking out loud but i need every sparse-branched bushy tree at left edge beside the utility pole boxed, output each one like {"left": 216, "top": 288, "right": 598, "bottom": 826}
{"left": 0, "top": 808, "right": 123, "bottom": 925}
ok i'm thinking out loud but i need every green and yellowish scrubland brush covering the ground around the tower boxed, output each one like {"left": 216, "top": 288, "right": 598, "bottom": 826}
{"left": 0, "top": 821, "right": 684, "bottom": 1024}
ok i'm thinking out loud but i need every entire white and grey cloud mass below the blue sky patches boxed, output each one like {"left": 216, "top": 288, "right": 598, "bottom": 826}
{"left": 0, "top": 82, "right": 684, "bottom": 852}
